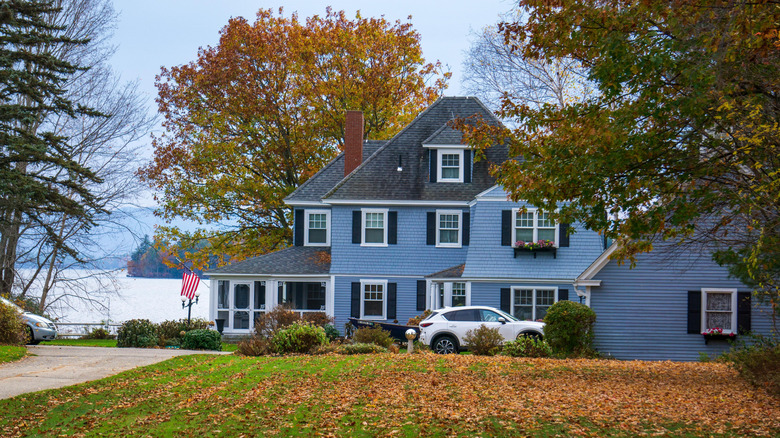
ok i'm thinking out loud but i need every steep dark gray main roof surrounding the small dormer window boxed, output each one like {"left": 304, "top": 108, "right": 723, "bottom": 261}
{"left": 324, "top": 97, "right": 507, "bottom": 202}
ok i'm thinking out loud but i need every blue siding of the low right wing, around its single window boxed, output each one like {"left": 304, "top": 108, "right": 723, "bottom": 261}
{"left": 591, "top": 243, "right": 771, "bottom": 361}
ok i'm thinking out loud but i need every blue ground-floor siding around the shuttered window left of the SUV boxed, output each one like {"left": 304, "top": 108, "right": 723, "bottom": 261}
{"left": 334, "top": 274, "right": 423, "bottom": 333}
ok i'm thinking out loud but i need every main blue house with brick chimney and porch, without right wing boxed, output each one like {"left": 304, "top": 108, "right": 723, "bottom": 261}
{"left": 208, "top": 97, "right": 772, "bottom": 358}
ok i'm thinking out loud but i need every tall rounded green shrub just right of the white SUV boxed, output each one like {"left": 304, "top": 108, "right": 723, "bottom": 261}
{"left": 544, "top": 301, "right": 596, "bottom": 357}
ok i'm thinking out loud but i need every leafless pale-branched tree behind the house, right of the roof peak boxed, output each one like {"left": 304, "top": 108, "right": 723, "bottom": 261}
{"left": 463, "top": 9, "right": 594, "bottom": 110}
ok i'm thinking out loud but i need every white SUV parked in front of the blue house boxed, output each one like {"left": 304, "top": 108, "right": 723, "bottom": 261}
{"left": 420, "top": 306, "right": 544, "bottom": 354}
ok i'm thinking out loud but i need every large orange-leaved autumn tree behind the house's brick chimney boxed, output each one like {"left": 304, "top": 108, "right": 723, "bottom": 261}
{"left": 140, "top": 9, "right": 449, "bottom": 267}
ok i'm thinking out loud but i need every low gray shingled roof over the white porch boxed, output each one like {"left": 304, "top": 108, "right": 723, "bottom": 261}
{"left": 207, "top": 246, "right": 330, "bottom": 275}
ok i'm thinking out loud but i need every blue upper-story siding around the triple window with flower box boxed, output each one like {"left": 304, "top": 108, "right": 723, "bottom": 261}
{"left": 463, "top": 189, "right": 604, "bottom": 280}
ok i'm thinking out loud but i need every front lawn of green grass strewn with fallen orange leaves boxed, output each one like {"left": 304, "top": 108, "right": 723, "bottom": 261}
{"left": 0, "top": 354, "right": 780, "bottom": 437}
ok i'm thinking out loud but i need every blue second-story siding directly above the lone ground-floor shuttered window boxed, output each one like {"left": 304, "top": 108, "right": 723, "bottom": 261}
{"left": 330, "top": 206, "right": 473, "bottom": 276}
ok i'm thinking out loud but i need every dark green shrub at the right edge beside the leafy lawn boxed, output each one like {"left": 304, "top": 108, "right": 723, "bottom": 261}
{"left": 718, "top": 335, "right": 780, "bottom": 397}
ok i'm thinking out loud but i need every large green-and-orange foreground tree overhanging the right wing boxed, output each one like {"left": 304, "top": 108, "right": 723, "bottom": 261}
{"left": 469, "top": 0, "right": 780, "bottom": 309}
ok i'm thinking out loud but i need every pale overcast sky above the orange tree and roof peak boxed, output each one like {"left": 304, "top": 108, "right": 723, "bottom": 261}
{"left": 112, "top": 0, "right": 512, "bottom": 113}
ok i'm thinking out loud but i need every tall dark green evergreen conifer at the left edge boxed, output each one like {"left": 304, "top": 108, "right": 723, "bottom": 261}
{"left": 0, "top": 0, "right": 101, "bottom": 296}
